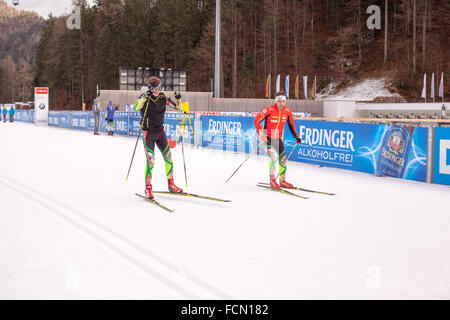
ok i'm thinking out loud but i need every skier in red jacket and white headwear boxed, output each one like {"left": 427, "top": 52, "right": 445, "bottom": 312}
{"left": 253, "top": 91, "right": 302, "bottom": 189}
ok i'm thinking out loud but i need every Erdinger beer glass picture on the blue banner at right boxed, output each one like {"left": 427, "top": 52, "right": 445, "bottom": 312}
{"left": 376, "top": 126, "right": 414, "bottom": 178}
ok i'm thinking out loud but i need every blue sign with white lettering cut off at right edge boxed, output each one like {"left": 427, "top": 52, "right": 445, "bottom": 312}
{"left": 433, "top": 128, "right": 450, "bottom": 185}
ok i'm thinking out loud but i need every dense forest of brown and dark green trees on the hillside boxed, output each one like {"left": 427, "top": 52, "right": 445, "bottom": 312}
{"left": 0, "top": 0, "right": 450, "bottom": 109}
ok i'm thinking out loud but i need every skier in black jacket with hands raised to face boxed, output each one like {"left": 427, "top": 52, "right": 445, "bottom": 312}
{"left": 134, "top": 76, "right": 183, "bottom": 199}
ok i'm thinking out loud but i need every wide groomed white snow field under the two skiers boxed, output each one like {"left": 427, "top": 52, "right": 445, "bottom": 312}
{"left": 0, "top": 123, "right": 450, "bottom": 299}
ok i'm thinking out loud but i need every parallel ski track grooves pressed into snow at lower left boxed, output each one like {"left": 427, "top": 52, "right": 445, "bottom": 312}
{"left": 0, "top": 174, "right": 233, "bottom": 300}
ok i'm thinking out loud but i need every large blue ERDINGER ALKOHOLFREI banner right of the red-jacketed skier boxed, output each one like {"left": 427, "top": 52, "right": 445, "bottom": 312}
{"left": 286, "top": 120, "right": 427, "bottom": 182}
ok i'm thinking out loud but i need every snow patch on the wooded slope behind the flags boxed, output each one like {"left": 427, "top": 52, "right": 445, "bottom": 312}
{"left": 317, "top": 78, "right": 400, "bottom": 101}
